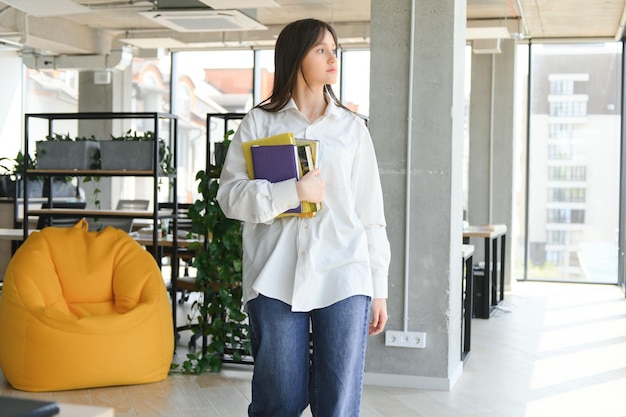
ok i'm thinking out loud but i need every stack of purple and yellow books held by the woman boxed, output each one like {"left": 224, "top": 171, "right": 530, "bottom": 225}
{"left": 243, "top": 132, "right": 322, "bottom": 218}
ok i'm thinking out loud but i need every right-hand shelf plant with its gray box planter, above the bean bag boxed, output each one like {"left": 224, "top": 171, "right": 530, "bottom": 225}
{"left": 100, "top": 129, "right": 175, "bottom": 174}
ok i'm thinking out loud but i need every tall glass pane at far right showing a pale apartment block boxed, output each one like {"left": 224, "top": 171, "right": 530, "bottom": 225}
{"left": 527, "top": 43, "right": 622, "bottom": 283}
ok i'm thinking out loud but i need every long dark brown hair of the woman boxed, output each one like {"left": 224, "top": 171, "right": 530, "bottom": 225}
{"left": 256, "top": 19, "right": 345, "bottom": 112}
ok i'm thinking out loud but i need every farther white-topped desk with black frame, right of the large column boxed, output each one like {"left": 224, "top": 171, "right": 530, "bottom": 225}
{"left": 463, "top": 224, "right": 507, "bottom": 319}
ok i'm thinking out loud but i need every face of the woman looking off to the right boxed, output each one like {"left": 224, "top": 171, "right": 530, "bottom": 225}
{"left": 299, "top": 30, "right": 337, "bottom": 89}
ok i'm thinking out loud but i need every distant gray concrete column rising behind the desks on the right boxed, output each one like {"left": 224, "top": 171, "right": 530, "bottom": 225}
{"left": 468, "top": 40, "right": 521, "bottom": 287}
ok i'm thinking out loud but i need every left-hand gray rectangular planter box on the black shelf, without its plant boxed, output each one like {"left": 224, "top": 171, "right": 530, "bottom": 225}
{"left": 36, "top": 140, "right": 100, "bottom": 170}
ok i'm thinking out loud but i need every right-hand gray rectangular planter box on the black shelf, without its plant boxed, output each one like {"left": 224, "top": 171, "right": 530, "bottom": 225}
{"left": 100, "top": 140, "right": 154, "bottom": 170}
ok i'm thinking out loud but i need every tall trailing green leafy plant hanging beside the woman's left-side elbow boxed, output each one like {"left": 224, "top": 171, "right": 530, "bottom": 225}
{"left": 173, "top": 130, "right": 251, "bottom": 374}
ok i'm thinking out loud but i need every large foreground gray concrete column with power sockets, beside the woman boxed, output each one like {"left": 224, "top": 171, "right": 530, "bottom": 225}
{"left": 366, "top": 0, "right": 466, "bottom": 390}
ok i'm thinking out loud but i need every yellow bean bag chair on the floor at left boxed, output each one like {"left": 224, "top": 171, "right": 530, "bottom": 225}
{"left": 0, "top": 219, "right": 174, "bottom": 391}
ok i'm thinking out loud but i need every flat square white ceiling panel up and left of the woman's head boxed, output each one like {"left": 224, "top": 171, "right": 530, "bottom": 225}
{"left": 139, "top": 9, "right": 267, "bottom": 32}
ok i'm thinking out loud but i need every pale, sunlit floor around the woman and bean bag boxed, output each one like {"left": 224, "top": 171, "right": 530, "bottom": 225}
{"left": 0, "top": 282, "right": 626, "bottom": 417}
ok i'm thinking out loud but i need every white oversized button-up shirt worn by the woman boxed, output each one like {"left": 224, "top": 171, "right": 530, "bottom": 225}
{"left": 217, "top": 99, "right": 390, "bottom": 311}
